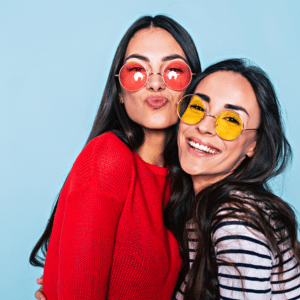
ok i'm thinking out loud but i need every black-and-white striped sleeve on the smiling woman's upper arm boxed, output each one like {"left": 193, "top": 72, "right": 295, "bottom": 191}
{"left": 213, "top": 219, "right": 272, "bottom": 300}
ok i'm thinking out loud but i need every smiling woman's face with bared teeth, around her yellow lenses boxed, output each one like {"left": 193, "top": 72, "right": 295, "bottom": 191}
{"left": 178, "top": 71, "right": 260, "bottom": 192}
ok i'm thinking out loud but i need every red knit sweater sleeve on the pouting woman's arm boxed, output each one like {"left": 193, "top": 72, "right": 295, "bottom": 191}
{"left": 44, "top": 133, "right": 132, "bottom": 300}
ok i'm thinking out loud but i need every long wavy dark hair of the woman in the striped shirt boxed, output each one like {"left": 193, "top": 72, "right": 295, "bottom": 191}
{"left": 165, "top": 59, "right": 300, "bottom": 300}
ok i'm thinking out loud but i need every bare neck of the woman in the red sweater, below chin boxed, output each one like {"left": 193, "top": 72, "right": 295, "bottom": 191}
{"left": 136, "top": 128, "right": 166, "bottom": 167}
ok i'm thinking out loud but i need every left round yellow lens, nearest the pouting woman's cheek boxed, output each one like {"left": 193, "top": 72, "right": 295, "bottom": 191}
{"left": 177, "top": 95, "right": 205, "bottom": 125}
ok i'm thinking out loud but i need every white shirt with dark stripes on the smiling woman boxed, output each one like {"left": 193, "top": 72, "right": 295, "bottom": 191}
{"left": 175, "top": 210, "right": 300, "bottom": 300}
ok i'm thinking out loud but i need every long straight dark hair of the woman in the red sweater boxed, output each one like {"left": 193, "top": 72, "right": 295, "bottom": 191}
{"left": 29, "top": 15, "right": 201, "bottom": 267}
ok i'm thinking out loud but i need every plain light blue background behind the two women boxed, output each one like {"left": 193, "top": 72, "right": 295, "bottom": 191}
{"left": 0, "top": 0, "right": 300, "bottom": 300}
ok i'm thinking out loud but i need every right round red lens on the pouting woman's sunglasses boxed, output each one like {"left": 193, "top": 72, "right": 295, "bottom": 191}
{"left": 164, "top": 61, "right": 192, "bottom": 91}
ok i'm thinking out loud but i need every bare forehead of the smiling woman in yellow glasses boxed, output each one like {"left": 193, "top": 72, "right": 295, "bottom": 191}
{"left": 195, "top": 71, "right": 259, "bottom": 114}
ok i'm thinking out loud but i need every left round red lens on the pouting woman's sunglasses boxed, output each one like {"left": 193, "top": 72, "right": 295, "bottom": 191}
{"left": 119, "top": 62, "right": 147, "bottom": 92}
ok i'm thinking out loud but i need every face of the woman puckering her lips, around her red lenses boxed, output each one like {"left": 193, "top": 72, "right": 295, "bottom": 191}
{"left": 120, "top": 28, "right": 186, "bottom": 130}
